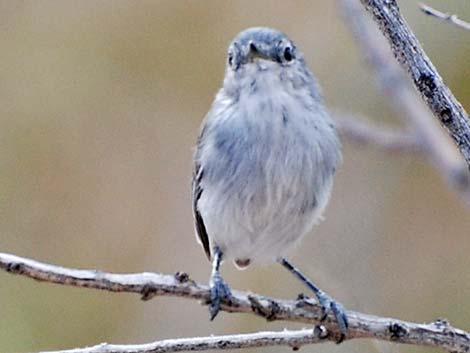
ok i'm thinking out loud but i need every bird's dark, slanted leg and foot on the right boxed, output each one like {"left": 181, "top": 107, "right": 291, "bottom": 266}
{"left": 278, "top": 258, "right": 348, "bottom": 343}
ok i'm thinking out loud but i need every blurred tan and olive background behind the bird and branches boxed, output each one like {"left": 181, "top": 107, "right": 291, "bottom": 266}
{"left": 0, "top": 0, "right": 470, "bottom": 352}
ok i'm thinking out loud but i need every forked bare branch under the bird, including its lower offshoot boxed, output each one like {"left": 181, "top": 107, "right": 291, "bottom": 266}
{"left": 0, "top": 253, "right": 470, "bottom": 353}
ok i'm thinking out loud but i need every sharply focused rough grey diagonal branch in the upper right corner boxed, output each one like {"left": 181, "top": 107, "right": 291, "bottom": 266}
{"left": 356, "top": 0, "right": 470, "bottom": 168}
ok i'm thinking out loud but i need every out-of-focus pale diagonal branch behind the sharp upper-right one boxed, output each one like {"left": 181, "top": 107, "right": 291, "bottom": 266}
{"left": 339, "top": 0, "right": 470, "bottom": 204}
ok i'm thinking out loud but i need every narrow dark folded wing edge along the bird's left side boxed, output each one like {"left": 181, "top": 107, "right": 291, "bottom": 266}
{"left": 191, "top": 128, "right": 211, "bottom": 260}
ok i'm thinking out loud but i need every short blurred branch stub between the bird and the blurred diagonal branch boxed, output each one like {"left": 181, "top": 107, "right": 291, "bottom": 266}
{"left": 333, "top": 113, "right": 422, "bottom": 153}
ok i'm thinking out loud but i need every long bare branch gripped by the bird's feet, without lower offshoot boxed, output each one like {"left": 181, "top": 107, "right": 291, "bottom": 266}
{"left": 0, "top": 253, "right": 470, "bottom": 353}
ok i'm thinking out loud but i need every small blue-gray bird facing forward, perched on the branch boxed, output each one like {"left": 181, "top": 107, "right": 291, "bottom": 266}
{"left": 192, "top": 27, "right": 347, "bottom": 340}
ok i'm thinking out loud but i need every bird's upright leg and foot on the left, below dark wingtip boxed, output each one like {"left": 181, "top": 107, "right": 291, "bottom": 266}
{"left": 209, "top": 246, "right": 232, "bottom": 321}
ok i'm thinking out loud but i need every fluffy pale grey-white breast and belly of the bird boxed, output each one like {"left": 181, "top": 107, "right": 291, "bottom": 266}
{"left": 198, "top": 64, "right": 339, "bottom": 263}
